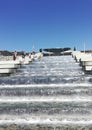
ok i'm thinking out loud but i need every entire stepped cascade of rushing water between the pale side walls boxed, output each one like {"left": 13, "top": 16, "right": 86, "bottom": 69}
{"left": 0, "top": 56, "right": 92, "bottom": 130}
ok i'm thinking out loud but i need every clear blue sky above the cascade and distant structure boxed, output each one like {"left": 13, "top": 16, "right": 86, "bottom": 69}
{"left": 0, "top": 0, "right": 92, "bottom": 51}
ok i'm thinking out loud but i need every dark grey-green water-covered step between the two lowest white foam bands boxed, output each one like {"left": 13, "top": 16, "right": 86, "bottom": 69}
{"left": 0, "top": 101, "right": 92, "bottom": 117}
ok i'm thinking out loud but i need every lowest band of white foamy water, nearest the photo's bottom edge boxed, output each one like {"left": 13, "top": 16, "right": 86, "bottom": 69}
{"left": 0, "top": 118, "right": 92, "bottom": 126}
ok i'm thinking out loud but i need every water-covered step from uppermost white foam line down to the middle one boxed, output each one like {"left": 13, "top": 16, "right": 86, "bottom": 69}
{"left": 0, "top": 84, "right": 92, "bottom": 98}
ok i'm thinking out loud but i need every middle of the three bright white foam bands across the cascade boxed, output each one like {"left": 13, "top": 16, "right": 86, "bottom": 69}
{"left": 0, "top": 96, "right": 92, "bottom": 103}
